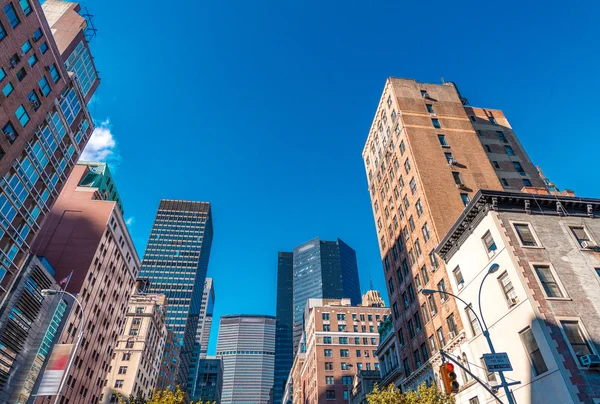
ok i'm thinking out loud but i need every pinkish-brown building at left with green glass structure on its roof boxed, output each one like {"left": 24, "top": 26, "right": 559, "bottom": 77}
{"left": 32, "top": 163, "right": 140, "bottom": 403}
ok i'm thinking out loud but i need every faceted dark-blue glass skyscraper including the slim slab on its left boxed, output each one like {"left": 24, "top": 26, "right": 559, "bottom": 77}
{"left": 273, "top": 238, "right": 361, "bottom": 404}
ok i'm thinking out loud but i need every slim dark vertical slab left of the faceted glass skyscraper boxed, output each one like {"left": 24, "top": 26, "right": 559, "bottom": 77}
{"left": 273, "top": 252, "right": 294, "bottom": 404}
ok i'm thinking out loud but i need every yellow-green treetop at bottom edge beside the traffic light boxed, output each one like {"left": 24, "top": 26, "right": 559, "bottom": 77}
{"left": 367, "top": 383, "right": 454, "bottom": 404}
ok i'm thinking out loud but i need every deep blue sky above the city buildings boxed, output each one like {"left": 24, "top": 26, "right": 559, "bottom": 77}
{"left": 83, "top": 0, "right": 600, "bottom": 352}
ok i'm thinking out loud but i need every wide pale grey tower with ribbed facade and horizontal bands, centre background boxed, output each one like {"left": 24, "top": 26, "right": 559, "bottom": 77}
{"left": 217, "top": 314, "right": 275, "bottom": 404}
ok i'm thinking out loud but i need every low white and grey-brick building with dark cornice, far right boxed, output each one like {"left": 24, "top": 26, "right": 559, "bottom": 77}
{"left": 432, "top": 191, "right": 600, "bottom": 404}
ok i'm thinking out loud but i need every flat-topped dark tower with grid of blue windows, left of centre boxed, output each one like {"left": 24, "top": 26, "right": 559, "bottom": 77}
{"left": 140, "top": 199, "right": 213, "bottom": 388}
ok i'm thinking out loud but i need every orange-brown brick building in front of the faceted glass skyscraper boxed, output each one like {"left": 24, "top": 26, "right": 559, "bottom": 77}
{"left": 285, "top": 291, "right": 390, "bottom": 404}
